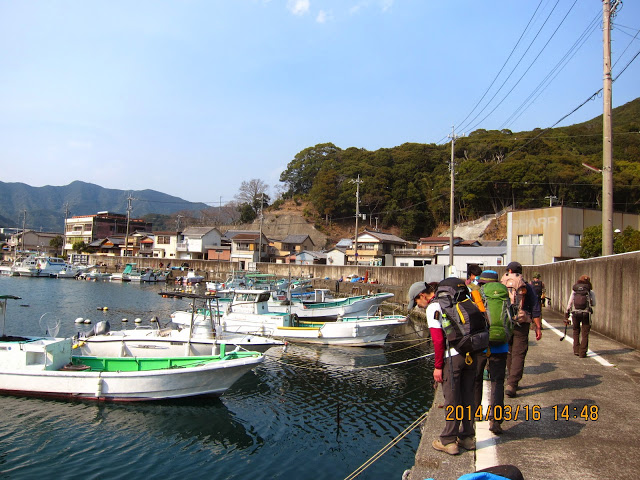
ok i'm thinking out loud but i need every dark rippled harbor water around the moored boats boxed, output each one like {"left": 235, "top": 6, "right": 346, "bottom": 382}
{"left": 0, "top": 277, "right": 433, "bottom": 479}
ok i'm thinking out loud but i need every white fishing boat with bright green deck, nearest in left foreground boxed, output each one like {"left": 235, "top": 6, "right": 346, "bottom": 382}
{"left": 0, "top": 295, "right": 264, "bottom": 401}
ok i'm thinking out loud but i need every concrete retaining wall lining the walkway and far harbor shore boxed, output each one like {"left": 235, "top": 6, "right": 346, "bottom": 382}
{"left": 86, "top": 252, "right": 640, "bottom": 349}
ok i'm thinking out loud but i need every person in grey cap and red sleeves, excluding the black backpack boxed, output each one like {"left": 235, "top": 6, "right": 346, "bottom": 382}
{"left": 409, "top": 282, "right": 478, "bottom": 455}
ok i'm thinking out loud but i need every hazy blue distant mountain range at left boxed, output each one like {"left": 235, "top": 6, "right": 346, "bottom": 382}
{"left": 0, "top": 181, "right": 210, "bottom": 232}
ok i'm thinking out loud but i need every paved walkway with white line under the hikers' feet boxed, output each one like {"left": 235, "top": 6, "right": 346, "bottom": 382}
{"left": 405, "top": 309, "right": 640, "bottom": 480}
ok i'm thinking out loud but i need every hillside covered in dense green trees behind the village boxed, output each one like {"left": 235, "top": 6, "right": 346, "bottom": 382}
{"left": 276, "top": 99, "right": 640, "bottom": 238}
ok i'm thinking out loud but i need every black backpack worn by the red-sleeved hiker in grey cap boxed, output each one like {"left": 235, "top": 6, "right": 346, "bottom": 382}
{"left": 435, "top": 277, "right": 489, "bottom": 357}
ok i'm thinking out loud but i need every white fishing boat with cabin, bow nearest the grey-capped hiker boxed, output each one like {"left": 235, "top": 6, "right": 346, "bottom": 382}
{"left": 214, "top": 290, "right": 406, "bottom": 346}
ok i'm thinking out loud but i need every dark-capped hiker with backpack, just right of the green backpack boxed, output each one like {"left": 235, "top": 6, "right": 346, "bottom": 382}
{"left": 500, "top": 262, "right": 542, "bottom": 397}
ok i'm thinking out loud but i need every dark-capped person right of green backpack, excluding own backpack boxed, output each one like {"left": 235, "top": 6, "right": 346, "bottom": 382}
{"left": 503, "top": 262, "right": 542, "bottom": 397}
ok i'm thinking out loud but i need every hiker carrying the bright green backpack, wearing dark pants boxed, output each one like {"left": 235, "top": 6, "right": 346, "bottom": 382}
{"left": 475, "top": 270, "right": 514, "bottom": 435}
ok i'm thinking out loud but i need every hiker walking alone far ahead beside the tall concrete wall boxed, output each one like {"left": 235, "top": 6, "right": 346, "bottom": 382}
{"left": 564, "top": 275, "right": 596, "bottom": 358}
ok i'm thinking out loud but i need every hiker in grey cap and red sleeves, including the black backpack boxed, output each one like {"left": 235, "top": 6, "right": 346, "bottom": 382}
{"left": 409, "top": 277, "right": 489, "bottom": 455}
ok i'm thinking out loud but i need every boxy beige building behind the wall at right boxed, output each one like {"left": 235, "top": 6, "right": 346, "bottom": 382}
{"left": 506, "top": 206, "right": 640, "bottom": 265}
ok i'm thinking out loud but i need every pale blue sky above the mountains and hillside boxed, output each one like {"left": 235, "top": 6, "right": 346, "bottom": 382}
{"left": 0, "top": 0, "right": 640, "bottom": 206}
